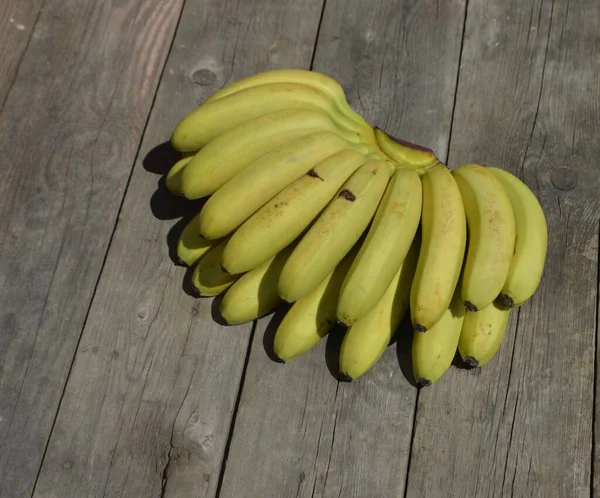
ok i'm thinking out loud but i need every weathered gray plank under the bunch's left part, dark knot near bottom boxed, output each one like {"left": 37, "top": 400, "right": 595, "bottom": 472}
{"left": 29, "top": 0, "right": 321, "bottom": 498}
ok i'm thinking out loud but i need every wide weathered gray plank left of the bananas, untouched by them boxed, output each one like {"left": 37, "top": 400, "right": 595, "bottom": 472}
{"left": 0, "top": 0, "right": 186, "bottom": 498}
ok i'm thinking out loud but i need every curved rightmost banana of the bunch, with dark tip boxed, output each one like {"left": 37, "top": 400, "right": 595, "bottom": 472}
{"left": 488, "top": 167, "right": 548, "bottom": 307}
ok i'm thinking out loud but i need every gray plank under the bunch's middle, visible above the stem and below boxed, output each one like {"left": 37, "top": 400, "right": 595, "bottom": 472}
{"left": 221, "top": 0, "right": 464, "bottom": 498}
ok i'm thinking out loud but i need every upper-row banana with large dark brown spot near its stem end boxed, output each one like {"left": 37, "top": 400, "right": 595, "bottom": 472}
{"left": 279, "top": 161, "right": 391, "bottom": 303}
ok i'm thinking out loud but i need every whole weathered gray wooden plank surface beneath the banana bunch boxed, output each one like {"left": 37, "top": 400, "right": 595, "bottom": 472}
{"left": 0, "top": 0, "right": 600, "bottom": 498}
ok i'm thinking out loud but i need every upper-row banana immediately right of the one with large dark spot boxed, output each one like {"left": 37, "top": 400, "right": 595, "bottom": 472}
{"left": 337, "top": 169, "right": 422, "bottom": 326}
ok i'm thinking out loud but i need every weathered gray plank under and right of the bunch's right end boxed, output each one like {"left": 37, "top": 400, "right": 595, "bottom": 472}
{"left": 408, "top": 0, "right": 600, "bottom": 498}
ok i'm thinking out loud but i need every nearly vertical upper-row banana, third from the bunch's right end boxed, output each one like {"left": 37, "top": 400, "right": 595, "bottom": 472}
{"left": 410, "top": 164, "right": 466, "bottom": 332}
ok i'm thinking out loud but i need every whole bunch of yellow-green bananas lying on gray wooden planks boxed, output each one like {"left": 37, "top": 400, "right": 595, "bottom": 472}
{"left": 166, "top": 70, "right": 547, "bottom": 386}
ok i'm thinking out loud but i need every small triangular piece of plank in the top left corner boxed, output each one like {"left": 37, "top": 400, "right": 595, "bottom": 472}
{"left": 0, "top": 0, "right": 42, "bottom": 113}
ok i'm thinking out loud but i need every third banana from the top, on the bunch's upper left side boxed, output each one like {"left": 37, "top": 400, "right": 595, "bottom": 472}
{"left": 181, "top": 109, "right": 359, "bottom": 199}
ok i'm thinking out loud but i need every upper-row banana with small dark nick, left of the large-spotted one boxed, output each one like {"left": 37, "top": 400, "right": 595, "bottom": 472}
{"left": 222, "top": 150, "right": 366, "bottom": 273}
